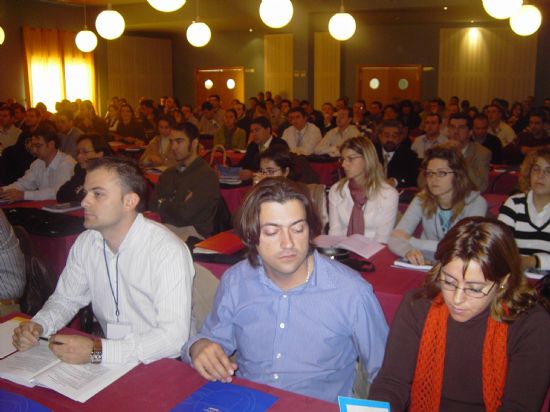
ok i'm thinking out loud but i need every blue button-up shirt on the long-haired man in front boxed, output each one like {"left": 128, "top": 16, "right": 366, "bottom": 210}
{"left": 182, "top": 252, "right": 388, "bottom": 402}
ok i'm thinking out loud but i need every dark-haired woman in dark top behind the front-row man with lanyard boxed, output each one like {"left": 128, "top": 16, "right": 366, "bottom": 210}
{"left": 56, "top": 134, "right": 112, "bottom": 203}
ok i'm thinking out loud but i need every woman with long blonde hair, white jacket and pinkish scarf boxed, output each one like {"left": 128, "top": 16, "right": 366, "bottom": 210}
{"left": 328, "top": 137, "right": 399, "bottom": 243}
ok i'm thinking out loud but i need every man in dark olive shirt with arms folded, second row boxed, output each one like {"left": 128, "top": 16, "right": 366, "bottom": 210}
{"left": 151, "top": 123, "right": 220, "bottom": 240}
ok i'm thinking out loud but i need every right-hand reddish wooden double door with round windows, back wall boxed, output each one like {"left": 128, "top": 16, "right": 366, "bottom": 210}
{"left": 357, "top": 65, "right": 422, "bottom": 104}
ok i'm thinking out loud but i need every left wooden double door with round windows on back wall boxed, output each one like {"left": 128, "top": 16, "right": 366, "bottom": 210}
{"left": 195, "top": 66, "right": 244, "bottom": 109}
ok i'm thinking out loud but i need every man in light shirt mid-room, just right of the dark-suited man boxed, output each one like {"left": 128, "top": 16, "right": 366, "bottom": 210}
{"left": 282, "top": 107, "right": 321, "bottom": 156}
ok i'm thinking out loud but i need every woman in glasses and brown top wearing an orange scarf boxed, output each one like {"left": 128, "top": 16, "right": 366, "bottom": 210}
{"left": 369, "top": 217, "right": 550, "bottom": 412}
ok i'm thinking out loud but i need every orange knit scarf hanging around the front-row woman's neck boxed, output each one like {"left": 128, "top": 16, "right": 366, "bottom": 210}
{"left": 409, "top": 295, "right": 508, "bottom": 412}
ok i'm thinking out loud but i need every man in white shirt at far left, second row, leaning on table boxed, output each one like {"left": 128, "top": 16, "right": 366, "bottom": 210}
{"left": 0, "top": 126, "right": 76, "bottom": 202}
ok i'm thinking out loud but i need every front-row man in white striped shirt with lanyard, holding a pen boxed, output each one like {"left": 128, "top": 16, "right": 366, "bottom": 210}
{"left": 13, "top": 157, "right": 194, "bottom": 363}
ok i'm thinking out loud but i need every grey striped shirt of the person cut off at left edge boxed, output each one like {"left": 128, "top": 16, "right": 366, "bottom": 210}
{"left": 0, "top": 209, "right": 25, "bottom": 299}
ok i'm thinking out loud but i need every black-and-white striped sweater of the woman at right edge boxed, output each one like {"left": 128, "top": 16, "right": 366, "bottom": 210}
{"left": 498, "top": 191, "right": 550, "bottom": 270}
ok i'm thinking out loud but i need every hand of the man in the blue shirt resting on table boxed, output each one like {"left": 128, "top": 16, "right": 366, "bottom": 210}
{"left": 189, "top": 339, "right": 237, "bottom": 383}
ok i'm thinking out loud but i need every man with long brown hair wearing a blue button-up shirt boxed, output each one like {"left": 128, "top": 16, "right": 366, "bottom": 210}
{"left": 182, "top": 178, "right": 388, "bottom": 402}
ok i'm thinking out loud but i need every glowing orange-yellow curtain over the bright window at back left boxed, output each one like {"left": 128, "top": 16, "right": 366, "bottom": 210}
{"left": 23, "top": 27, "right": 96, "bottom": 111}
